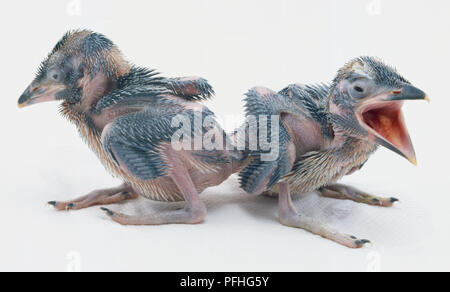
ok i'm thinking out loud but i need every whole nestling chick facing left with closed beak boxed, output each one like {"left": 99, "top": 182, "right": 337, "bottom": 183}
{"left": 19, "top": 30, "right": 243, "bottom": 225}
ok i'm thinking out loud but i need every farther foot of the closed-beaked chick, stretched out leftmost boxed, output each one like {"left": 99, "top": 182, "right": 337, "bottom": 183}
{"left": 48, "top": 183, "right": 139, "bottom": 211}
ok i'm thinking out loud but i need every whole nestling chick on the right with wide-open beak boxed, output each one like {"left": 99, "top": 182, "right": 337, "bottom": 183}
{"left": 240, "top": 57, "right": 428, "bottom": 248}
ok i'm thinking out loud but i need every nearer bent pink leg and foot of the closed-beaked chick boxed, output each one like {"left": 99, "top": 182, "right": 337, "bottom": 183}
{"left": 102, "top": 152, "right": 206, "bottom": 225}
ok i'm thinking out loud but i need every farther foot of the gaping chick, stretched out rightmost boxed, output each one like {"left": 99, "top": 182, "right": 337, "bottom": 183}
{"left": 319, "top": 184, "right": 398, "bottom": 207}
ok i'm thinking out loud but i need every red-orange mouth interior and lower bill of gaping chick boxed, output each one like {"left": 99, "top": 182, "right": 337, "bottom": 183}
{"left": 360, "top": 101, "right": 416, "bottom": 164}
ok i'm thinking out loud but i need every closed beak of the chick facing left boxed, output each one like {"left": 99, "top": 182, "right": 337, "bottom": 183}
{"left": 18, "top": 83, "right": 65, "bottom": 108}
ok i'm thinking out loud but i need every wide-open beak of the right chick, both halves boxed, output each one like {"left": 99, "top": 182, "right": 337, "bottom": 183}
{"left": 358, "top": 83, "right": 429, "bottom": 165}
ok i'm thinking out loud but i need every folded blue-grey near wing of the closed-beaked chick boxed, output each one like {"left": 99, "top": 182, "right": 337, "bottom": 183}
{"left": 102, "top": 100, "right": 230, "bottom": 181}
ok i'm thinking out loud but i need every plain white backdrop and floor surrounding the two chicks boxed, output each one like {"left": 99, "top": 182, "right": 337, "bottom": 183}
{"left": 0, "top": 0, "right": 450, "bottom": 271}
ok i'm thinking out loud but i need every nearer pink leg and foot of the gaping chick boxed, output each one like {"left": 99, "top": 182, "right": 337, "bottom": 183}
{"left": 278, "top": 183, "right": 370, "bottom": 248}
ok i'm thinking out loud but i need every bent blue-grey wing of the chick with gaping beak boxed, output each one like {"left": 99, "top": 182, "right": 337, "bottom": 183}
{"left": 240, "top": 84, "right": 334, "bottom": 194}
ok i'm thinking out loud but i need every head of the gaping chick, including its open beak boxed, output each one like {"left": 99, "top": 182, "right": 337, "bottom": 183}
{"left": 329, "top": 57, "right": 428, "bottom": 164}
